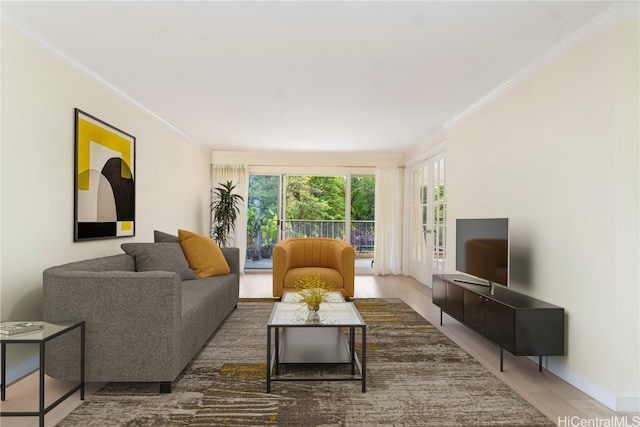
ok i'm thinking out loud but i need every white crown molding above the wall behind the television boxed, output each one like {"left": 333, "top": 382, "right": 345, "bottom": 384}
{"left": 443, "top": 2, "right": 638, "bottom": 129}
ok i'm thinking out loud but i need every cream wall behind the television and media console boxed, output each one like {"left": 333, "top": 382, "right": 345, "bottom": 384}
{"left": 447, "top": 23, "right": 640, "bottom": 411}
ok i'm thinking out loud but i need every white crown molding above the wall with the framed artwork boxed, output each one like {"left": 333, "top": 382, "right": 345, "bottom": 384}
{"left": 1, "top": 10, "right": 205, "bottom": 152}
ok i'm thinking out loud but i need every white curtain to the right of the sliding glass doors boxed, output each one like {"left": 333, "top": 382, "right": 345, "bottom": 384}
{"left": 373, "top": 167, "right": 404, "bottom": 276}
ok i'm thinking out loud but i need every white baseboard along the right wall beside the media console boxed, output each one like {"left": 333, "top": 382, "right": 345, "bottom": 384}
{"left": 531, "top": 357, "right": 640, "bottom": 412}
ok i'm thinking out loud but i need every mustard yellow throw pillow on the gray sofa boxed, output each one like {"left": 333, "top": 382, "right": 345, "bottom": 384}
{"left": 178, "top": 230, "right": 231, "bottom": 277}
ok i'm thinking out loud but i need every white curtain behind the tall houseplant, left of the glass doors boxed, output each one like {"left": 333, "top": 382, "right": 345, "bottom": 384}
{"left": 211, "top": 165, "right": 249, "bottom": 272}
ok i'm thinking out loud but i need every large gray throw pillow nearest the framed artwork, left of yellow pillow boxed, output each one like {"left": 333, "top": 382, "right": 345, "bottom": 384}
{"left": 120, "top": 243, "right": 198, "bottom": 280}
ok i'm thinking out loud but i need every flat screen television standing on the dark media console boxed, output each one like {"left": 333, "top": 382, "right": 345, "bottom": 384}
{"left": 456, "top": 218, "right": 509, "bottom": 286}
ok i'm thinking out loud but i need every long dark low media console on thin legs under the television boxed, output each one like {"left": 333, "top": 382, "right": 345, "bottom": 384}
{"left": 432, "top": 274, "right": 564, "bottom": 372}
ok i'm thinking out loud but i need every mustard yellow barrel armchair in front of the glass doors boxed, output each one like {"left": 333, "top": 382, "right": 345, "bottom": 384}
{"left": 273, "top": 238, "right": 355, "bottom": 298}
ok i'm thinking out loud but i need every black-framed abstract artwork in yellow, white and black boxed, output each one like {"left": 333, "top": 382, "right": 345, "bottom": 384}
{"left": 73, "top": 108, "right": 136, "bottom": 242}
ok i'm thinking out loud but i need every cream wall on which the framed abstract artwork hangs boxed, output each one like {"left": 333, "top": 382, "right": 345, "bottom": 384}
{"left": 0, "top": 25, "right": 211, "bottom": 381}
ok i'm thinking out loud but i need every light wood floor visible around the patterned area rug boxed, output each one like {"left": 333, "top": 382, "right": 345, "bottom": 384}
{"left": 0, "top": 272, "right": 640, "bottom": 427}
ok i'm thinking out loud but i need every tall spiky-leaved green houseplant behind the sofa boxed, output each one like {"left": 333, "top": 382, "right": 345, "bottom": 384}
{"left": 211, "top": 181, "right": 244, "bottom": 246}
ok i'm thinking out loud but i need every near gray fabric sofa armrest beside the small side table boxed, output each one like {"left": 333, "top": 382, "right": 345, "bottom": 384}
{"left": 43, "top": 267, "right": 182, "bottom": 381}
